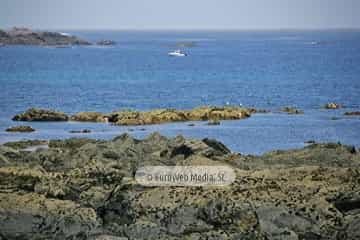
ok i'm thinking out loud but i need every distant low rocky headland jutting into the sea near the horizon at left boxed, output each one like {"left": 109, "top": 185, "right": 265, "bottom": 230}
{"left": 0, "top": 27, "right": 91, "bottom": 46}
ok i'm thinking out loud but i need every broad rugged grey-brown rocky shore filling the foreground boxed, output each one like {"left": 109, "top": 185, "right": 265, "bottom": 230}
{"left": 0, "top": 133, "right": 360, "bottom": 240}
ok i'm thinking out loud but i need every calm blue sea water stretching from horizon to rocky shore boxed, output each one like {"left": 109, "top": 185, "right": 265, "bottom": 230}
{"left": 0, "top": 31, "right": 360, "bottom": 154}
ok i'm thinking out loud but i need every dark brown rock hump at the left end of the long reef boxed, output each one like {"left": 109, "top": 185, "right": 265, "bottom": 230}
{"left": 12, "top": 108, "right": 69, "bottom": 122}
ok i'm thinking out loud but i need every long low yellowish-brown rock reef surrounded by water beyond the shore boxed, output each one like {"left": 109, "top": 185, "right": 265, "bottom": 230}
{"left": 13, "top": 107, "right": 256, "bottom": 126}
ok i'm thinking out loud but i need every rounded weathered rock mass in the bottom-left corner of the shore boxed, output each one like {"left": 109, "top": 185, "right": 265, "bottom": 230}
{"left": 0, "top": 193, "right": 101, "bottom": 239}
